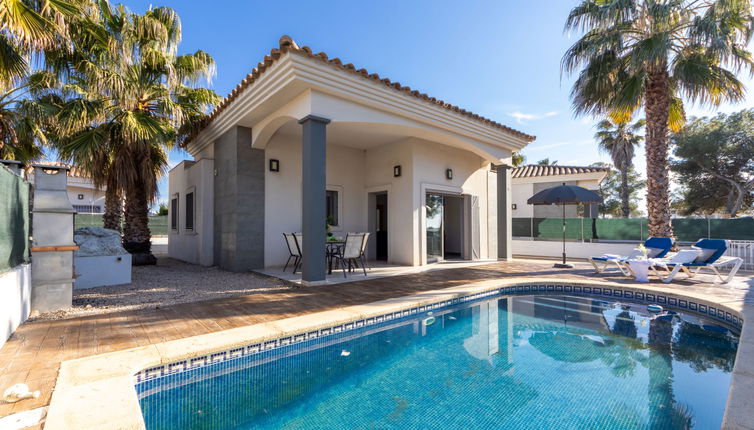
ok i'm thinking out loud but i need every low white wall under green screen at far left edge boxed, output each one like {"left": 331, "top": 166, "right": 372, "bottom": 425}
{"left": 0, "top": 264, "right": 31, "bottom": 347}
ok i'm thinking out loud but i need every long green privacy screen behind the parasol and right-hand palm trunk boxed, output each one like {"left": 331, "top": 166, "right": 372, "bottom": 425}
{"left": 512, "top": 217, "right": 754, "bottom": 242}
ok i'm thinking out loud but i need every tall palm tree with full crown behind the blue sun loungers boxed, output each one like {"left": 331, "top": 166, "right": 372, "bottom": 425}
{"left": 562, "top": 0, "right": 754, "bottom": 237}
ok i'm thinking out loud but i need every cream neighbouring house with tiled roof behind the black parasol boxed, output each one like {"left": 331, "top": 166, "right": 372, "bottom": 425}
{"left": 511, "top": 165, "right": 608, "bottom": 218}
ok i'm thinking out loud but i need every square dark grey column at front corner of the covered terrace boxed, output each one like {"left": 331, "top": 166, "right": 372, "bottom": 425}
{"left": 299, "top": 115, "right": 330, "bottom": 284}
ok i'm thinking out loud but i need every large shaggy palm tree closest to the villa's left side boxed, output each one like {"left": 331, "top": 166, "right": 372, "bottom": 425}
{"left": 50, "top": 4, "right": 219, "bottom": 264}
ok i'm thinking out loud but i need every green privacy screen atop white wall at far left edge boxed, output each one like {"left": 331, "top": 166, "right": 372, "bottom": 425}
{"left": 0, "top": 166, "right": 30, "bottom": 272}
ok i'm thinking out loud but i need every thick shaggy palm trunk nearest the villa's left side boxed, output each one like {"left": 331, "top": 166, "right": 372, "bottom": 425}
{"left": 123, "top": 178, "right": 157, "bottom": 266}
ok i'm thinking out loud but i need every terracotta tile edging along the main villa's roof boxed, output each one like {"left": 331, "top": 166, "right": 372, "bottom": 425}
{"left": 184, "top": 36, "right": 535, "bottom": 146}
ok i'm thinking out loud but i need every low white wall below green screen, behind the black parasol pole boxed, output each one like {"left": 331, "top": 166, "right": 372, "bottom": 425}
{"left": 513, "top": 239, "right": 639, "bottom": 258}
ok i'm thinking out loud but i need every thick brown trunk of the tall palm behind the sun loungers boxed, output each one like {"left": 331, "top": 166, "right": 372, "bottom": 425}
{"left": 644, "top": 67, "right": 673, "bottom": 237}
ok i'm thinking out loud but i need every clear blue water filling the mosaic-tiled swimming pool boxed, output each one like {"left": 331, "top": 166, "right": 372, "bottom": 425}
{"left": 140, "top": 296, "right": 738, "bottom": 430}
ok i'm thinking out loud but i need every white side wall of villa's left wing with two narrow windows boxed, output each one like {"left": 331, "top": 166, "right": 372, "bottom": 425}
{"left": 167, "top": 159, "right": 215, "bottom": 266}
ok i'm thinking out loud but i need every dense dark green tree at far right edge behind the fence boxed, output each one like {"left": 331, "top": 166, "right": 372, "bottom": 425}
{"left": 672, "top": 109, "right": 754, "bottom": 217}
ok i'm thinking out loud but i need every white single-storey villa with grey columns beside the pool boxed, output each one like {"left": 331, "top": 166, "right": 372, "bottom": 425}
{"left": 168, "top": 36, "right": 534, "bottom": 282}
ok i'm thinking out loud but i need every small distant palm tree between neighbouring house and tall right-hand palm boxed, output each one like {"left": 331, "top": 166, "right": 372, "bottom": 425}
{"left": 594, "top": 119, "right": 644, "bottom": 218}
